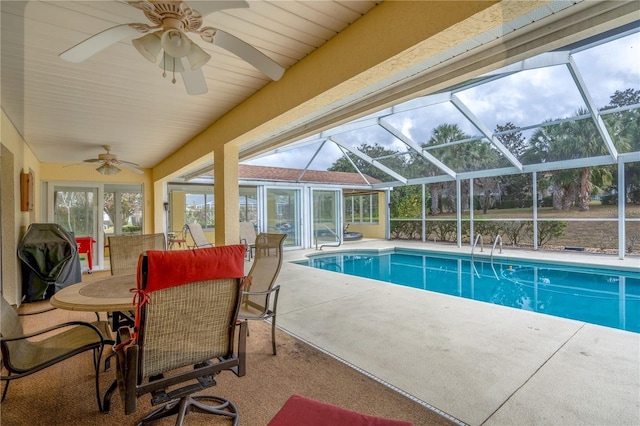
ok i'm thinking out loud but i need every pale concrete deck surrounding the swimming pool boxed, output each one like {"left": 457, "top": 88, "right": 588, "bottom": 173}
{"left": 277, "top": 240, "right": 640, "bottom": 425}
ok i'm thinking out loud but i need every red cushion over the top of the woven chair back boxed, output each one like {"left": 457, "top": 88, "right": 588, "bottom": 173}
{"left": 138, "top": 244, "right": 245, "bottom": 293}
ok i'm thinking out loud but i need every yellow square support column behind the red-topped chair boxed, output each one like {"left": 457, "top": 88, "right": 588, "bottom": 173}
{"left": 213, "top": 144, "right": 240, "bottom": 246}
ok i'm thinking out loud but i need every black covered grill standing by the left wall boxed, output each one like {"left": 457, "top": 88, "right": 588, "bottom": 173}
{"left": 18, "top": 223, "right": 82, "bottom": 302}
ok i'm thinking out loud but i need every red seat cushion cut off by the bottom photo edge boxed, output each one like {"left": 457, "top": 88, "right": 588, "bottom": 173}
{"left": 267, "top": 395, "right": 413, "bottom": 426}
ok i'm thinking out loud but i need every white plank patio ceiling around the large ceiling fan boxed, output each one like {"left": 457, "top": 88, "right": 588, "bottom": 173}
{"left": 0, "top": 0, "right": 379, "bottom": 167}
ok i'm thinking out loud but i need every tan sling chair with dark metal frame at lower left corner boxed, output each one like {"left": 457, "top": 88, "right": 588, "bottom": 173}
{"left": 0, "top": 297, "right": 111, "bottom": 411}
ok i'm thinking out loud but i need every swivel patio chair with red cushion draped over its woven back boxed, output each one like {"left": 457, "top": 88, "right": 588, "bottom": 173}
{"left": 103, "top": 245, "right": 246, "bottom": 425}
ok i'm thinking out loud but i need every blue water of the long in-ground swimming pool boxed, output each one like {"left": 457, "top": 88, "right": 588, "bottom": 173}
{"left": 296, "top": 248, "right": 640, "bottom": 333}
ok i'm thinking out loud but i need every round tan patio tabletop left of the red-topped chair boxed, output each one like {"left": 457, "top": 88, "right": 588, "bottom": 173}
{"left": 50, "top": 274, "right": 136, "bottom": 312}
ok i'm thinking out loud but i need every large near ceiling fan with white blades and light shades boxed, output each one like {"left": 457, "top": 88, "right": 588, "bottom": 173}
{"left": 59, "top": 0, "right": 284, "bottom": 95}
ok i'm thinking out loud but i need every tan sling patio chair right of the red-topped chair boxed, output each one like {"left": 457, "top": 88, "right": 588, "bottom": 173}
{"left": 239, "top": 233, "right": 287, "bottom": 355}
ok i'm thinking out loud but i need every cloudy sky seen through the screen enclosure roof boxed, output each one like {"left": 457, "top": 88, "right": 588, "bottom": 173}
{"left": 244, "top": 28, "right": 640, "bottom": 170}
